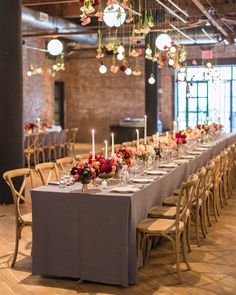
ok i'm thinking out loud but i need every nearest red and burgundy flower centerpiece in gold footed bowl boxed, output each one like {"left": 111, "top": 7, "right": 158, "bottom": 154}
{"left": 70, "top": 162, "right": 99, "bottom": 191}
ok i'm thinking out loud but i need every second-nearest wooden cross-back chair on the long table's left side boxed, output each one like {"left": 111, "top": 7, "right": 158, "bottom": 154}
{"left": 35, "top": 162, "right": 59, "bottom": 185}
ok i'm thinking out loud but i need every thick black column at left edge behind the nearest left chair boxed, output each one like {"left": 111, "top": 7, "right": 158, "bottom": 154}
{"left": 0, "top": 0, "right": 23, "bottom": 204}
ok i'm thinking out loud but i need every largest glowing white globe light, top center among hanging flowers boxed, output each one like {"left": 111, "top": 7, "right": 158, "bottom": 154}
{"left": 103, "top": 3, "right": 126, "bottom": 28}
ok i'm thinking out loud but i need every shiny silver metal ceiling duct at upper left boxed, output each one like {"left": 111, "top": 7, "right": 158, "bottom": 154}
{"left": 22, "top": 6, "right": 97, "bottom": 46}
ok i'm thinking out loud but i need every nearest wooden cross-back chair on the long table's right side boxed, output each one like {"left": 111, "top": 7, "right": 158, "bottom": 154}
{"left": 137, "top": 175, "right": 198, "bottom": 282}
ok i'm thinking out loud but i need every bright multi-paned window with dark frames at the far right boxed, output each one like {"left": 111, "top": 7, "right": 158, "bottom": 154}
{"left": 175, "top": 65, "right": 236, "bottom": 131}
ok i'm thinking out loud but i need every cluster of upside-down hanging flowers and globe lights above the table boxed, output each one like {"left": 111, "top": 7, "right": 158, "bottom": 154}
{"left": 76, "top": 0, "right": 189, "bottom": 76}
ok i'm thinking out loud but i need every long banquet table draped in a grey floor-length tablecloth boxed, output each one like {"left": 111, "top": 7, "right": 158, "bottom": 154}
{"left": 31, "top": 134, "right": 236, "bottom": 286}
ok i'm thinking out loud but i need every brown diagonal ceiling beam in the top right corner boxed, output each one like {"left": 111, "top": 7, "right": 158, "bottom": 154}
{"left": 192, "top": 0, "right": 234, "bottom": 44}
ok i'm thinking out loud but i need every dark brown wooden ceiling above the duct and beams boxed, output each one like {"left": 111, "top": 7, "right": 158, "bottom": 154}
{"left": 22, "top": 0, "right": 236, "bottom": 44}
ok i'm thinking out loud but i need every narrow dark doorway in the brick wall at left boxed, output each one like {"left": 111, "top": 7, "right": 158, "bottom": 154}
{"left": 54, "top": 82, "right": 64, "bottom": 129}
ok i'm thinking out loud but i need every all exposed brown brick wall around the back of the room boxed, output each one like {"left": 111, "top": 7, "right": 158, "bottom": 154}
{"left": 23, "top": 39, "right": 236, "bottom": 142}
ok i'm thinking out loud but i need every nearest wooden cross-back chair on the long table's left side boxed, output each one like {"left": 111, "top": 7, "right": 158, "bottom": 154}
{"left": 3, "top": 168, "right": 32, "bottom": 267}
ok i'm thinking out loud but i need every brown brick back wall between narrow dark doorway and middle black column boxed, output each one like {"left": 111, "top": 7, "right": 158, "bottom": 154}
{"left": 59, "top": 50, "right": 145, "bottom": 142}
